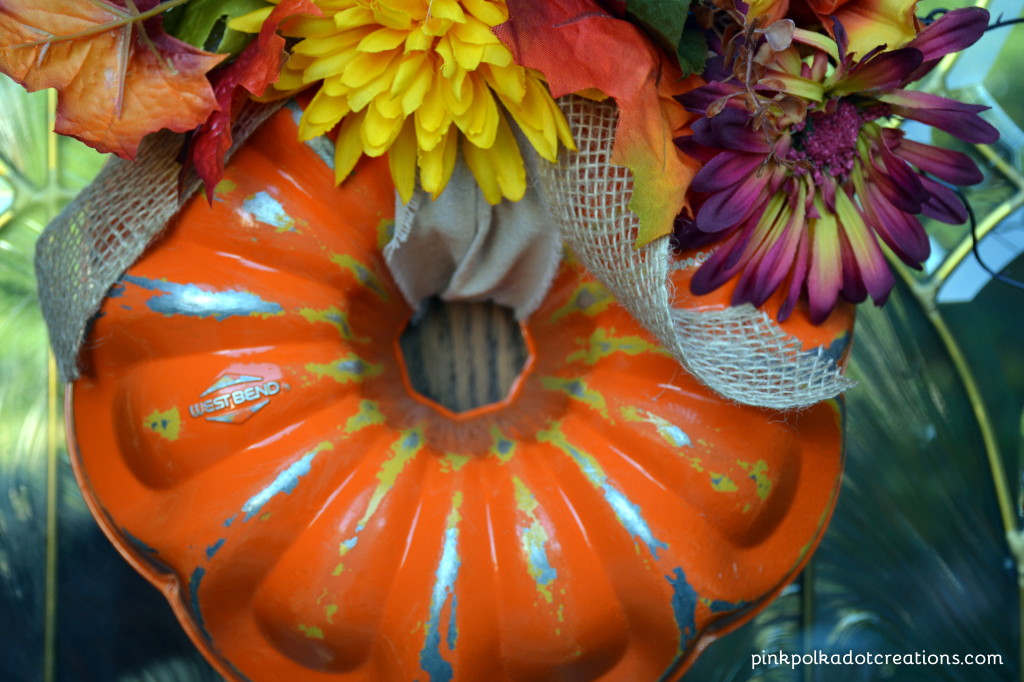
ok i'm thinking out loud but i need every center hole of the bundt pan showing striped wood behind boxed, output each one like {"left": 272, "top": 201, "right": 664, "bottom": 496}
{"left": 399, "top": 297, "right": 528, "bottom": 413}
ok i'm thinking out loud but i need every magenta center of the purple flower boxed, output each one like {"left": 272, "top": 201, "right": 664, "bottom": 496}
{"left": 788, "top": 99, "right": 886, "bottom": 184}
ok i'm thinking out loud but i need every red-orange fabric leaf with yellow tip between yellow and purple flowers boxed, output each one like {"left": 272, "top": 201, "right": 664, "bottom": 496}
{"left": 496, "top": 0, "right": 703, "bottom": 246}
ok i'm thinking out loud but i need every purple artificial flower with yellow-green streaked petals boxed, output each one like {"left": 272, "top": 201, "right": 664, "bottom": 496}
{"left": 679, "top": 8, "right": 998, "bottom": 322}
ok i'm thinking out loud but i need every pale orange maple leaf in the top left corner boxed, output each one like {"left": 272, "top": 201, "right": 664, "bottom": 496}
{"left": 0, "top": 0, "right": 224, "bottom": 159}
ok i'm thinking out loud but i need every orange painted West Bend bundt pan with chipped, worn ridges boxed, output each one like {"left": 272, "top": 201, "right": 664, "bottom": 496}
{"left": 68, "top": 112, "right": 849, "bottom": 682}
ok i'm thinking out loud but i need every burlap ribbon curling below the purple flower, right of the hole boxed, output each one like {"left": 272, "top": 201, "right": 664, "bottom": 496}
{"left": 539, "top": 95, "right": 853, "bottom": 410}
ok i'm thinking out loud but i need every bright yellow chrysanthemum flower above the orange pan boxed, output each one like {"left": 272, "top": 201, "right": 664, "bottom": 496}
{"left": 231, "top": 0, "right": 574, "bottom": 204}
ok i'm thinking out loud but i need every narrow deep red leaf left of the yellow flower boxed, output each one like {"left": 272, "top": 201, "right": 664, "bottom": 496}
{"left": 182, "top": 0, "right": 323, "bottom": 196}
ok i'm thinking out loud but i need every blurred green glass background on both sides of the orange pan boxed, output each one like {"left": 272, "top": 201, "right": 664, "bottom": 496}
{"left": 0, "top": 0, "right": 1024, "bottom": 682}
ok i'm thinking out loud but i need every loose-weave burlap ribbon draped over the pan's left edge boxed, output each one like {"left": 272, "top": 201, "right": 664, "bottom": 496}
{"left": 36, "top": 102, "right": 282, "bottom": 381}
